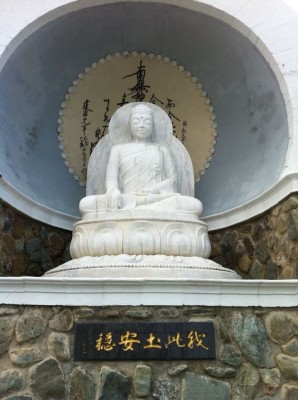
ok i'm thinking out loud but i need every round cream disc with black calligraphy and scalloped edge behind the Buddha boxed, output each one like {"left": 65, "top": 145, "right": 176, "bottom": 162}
{"left": 57, "top": 52, "right": 217, "bottom": 186}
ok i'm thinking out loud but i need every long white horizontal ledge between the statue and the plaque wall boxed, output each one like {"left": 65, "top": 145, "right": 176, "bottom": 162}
{"left": 0, "top": 277, "right": 298, "bottom": 307}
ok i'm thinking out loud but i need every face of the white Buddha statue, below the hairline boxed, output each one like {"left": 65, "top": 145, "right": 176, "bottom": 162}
{"left": 129, "top": 112, "right": 153, "bottom": 142}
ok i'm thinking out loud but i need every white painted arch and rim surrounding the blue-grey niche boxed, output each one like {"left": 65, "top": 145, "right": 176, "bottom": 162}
{"left": 0, "top": 0, "right": 298, "bottom": 230}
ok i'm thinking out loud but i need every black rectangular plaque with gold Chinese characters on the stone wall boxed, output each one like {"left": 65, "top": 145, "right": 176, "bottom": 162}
{"left": 74, "top": 321, "right": 215, "bottom": 361}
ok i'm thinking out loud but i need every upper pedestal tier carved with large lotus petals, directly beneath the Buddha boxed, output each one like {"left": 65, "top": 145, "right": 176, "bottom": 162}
{"left": 70, "top": 210, "right": 211, "bottom": 258}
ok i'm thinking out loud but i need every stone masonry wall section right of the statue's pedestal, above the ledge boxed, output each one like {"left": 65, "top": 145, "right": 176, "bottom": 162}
{"left": 209, "top": 193, "right": 298, "bottom": 279}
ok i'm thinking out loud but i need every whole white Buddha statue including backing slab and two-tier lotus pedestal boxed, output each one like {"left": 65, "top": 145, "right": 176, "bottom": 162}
{"left": 47, "top": 103, "right": 237, "bottom": 279}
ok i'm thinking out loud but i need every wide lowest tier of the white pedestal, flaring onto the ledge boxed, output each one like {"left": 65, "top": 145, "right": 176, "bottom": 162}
{"left": 45, "top": 254, "right": 241, "bottom": 281}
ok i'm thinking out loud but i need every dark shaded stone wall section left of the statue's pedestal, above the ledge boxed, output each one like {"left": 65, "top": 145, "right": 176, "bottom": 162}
{"left": 0, "top": 203, "right": 71, "bottom": 276}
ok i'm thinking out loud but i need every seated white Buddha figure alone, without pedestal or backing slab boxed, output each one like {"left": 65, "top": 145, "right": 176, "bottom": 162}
{"left": 80, "top": 103, "right": 202, "bottom": 219}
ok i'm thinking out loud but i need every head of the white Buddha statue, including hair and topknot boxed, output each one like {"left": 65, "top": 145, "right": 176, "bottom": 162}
{"left": 129, "top": 104, "right": 154, "bottom": 142}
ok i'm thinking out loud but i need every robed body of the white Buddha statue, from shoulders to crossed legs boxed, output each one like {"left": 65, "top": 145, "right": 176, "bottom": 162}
{"left": 80, "top": 142, "right": 202, "bottom": 219}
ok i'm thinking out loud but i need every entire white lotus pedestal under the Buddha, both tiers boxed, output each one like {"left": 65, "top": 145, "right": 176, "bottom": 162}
{"left": 45, "top": 210, "right": 240, "bottom": 280}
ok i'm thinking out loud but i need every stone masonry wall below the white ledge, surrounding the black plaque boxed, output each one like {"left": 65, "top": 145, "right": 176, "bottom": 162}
{"left": 0, "top": 306, "right": 298, "bottom": 400}
